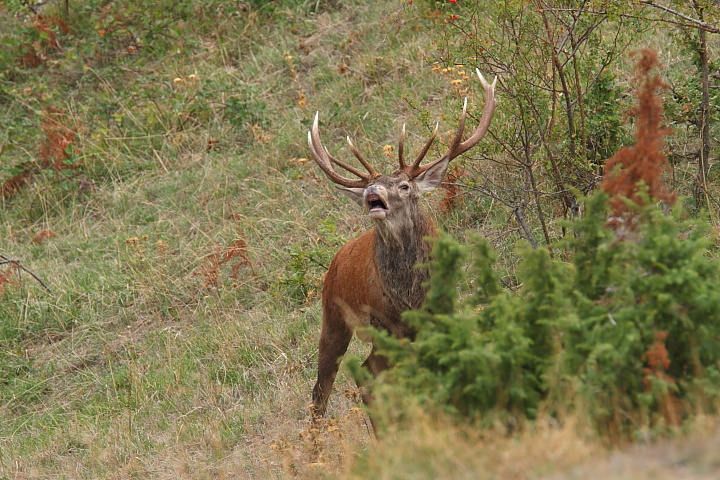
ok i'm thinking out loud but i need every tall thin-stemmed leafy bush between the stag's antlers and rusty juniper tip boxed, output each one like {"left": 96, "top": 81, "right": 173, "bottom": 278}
{"left": 422, "top": 0, "right": 648, "bottom": 246}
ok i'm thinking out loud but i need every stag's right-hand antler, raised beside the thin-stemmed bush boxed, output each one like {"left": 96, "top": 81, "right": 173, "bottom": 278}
{"left": 400, "top": 69, "right": 498, "bottom": 178}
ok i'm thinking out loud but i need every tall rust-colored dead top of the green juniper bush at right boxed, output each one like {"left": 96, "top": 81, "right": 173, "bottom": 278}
{"left": 603, "top": 50, "right": 675, "bottom": 230}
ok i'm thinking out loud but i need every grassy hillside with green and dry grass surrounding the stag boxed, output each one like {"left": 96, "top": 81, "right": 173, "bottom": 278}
{"left": 0, "top": 0, "right": 720, "bottom": 478}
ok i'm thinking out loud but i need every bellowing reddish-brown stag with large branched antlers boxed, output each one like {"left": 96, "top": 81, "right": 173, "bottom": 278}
{"left": 308, "top": 70, "right": 498, "bottom": 421}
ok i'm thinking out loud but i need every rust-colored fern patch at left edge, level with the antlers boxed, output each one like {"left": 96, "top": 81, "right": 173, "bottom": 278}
{"left": 0, "top": 108, "right": 77, "bottom": 200}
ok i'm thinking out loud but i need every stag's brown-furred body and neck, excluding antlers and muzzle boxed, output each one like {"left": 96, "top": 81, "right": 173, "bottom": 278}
{"left": 313, "top": 173, "right": 436, "bottom": 416}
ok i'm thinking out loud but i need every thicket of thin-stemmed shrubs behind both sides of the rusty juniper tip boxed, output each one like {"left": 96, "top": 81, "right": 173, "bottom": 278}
{"left": 428, "top": 0, "right": 720, "bottom": 246}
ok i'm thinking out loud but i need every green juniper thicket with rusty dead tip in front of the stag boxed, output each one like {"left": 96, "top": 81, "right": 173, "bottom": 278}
{"left": 377, "top": 51, "right": 720, "bottom": 440}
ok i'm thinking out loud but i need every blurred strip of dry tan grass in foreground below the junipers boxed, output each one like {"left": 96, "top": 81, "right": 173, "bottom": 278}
{"left": 255, "top": 411, "right": 720, "bottom": 480}
